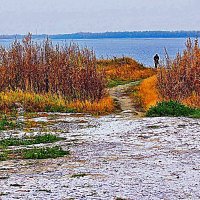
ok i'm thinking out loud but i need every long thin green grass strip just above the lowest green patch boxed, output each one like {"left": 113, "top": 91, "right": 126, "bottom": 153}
{"left": 0, "top": 134, "right": 63, "bottom": 147}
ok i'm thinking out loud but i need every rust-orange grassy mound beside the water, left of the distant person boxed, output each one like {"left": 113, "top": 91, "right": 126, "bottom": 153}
{"left": 98, "top": 57, "right": 156, "bottom": 81}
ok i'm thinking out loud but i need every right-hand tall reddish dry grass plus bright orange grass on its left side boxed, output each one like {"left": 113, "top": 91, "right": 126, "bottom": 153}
{"left": 139, "top": 39, "right": 200, "bottom": 109}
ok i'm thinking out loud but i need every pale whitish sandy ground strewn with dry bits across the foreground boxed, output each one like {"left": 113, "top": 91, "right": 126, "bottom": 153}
{"left": 0, "top": 114, "right": 200, "bottom": 200}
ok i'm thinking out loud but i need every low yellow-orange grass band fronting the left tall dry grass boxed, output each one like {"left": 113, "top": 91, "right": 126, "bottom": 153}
{"left": 0, "top": 91, "right": 114, "bottom": 115}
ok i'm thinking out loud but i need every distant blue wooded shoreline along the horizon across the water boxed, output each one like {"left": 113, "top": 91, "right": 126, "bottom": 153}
{"left": 0, "top": 31, "right": 200, "bottom": 39}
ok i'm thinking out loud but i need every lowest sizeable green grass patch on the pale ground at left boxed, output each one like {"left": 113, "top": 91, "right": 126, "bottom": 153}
{"left": 21, "top": 146, "right": 69, "bottom": 159}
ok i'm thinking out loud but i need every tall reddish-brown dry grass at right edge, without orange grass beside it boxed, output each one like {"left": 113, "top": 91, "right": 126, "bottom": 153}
{"left": 157, "top": 39, "right": 200, "bottom": 106}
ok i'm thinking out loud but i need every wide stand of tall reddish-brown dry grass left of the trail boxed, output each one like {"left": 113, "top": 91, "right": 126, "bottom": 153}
{"left": 0, "top": 34, "right": 105, "bottom": 102}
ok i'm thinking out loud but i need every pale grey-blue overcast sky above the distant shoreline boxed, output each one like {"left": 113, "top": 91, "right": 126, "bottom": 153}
{"left": 0, "top": 0, "right": 200, "bottom": 35}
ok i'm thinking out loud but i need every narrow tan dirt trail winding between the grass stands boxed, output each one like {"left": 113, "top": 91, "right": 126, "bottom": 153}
{"left": 109, "top": 81, "right": 140, "bottom": 115}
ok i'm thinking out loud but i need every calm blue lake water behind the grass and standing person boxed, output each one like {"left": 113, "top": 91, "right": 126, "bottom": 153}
{"left": 0, "top": 38, "right": 186, "bottom": 66}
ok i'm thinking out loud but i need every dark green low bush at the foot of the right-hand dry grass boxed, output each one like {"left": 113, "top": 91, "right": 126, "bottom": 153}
{"left": 146, "top": 101, "right": 200, "bottom": 118}
